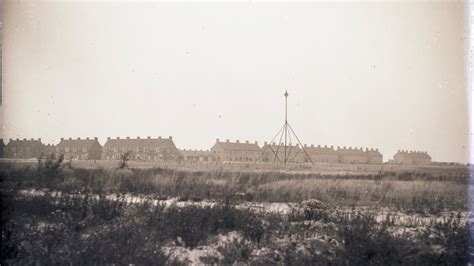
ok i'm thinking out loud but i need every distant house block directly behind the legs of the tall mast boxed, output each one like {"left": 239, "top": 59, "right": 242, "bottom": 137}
{"left": 261, "top": 142, "right": 306, "bottom": 163}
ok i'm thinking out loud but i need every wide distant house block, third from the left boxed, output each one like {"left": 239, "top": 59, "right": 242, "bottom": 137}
{"left": 102, "top": 136, "right": 181, "bottom": 161}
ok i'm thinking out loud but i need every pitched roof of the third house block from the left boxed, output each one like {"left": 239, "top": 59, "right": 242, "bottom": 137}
{"left": 104, "top": 138, "right": 176, "bottom": 149}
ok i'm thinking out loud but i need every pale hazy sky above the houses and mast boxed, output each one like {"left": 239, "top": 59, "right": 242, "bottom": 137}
{"left": 0, "top": 1, "right": 470, "bottom": 163}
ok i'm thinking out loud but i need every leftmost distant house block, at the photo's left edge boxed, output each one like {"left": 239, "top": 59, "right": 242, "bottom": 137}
{"left": 4, "top": 139, "right": 44, "bottom": 159}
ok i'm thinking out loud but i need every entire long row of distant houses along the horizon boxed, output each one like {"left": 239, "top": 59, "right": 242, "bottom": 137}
{"left": 0, "top": 136, "right": 431, "bottom": 164}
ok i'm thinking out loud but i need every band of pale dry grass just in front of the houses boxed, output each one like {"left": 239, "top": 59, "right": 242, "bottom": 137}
{"left": 0, "top": 159, "right": 468, "bottom": 213}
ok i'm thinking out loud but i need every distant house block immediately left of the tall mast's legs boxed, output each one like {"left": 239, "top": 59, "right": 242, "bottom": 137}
{"left": 211, "top": 139, "right": 261, "bottom": 162}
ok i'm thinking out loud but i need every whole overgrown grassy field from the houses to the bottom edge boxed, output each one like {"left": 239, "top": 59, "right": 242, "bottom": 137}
{"left": 0, "top": 160, "right": 469, "bottom": 265}
